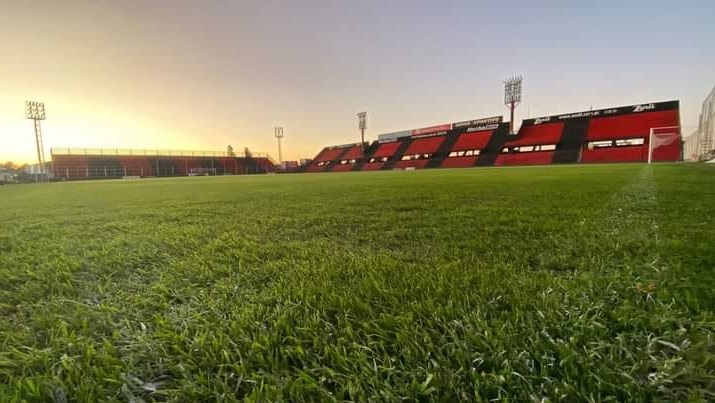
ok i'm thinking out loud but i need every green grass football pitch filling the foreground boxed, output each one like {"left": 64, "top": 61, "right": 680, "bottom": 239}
{"left": 0, "top": 164, "right": 715, "bottom": 402}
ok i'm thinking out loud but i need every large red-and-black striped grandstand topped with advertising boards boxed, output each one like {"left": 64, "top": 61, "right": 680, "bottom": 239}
{"left": 305, "top": 101, "right": 682, "bottom": 172}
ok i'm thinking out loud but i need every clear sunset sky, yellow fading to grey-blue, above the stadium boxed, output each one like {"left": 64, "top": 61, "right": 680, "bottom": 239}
{"left": 0, "top": 0, "right": 715, "bottom": 162}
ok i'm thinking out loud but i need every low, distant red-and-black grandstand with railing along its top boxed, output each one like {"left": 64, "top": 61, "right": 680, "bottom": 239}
{"left": 50, "top": 148, "right": 276, "bottom": 180}
